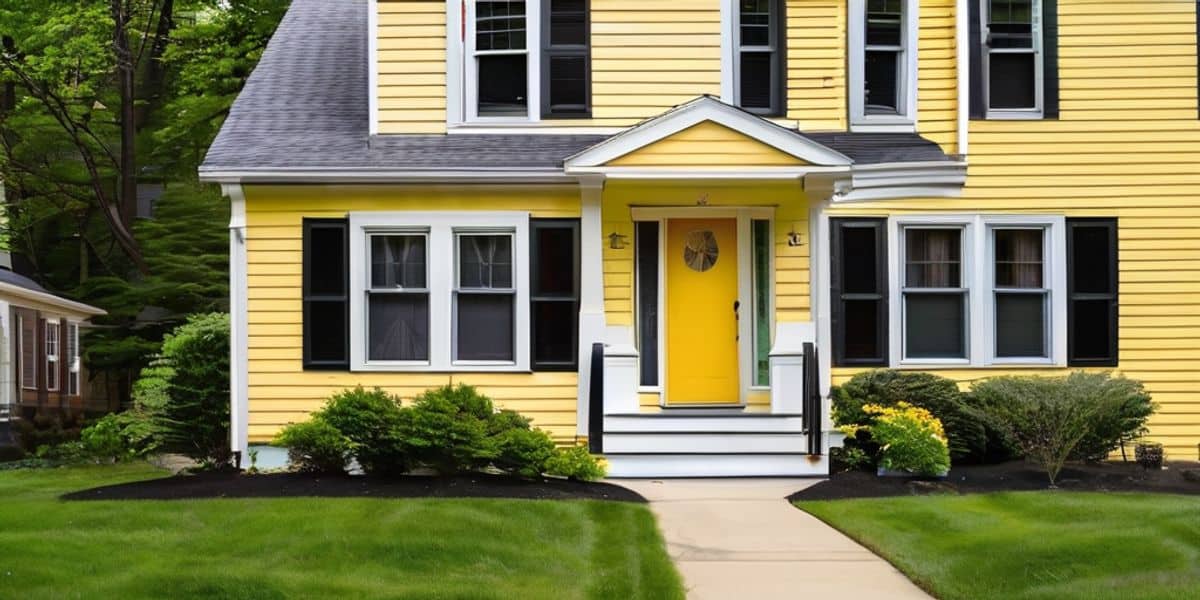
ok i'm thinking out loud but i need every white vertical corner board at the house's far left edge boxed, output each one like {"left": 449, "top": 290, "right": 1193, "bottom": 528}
{"left": 221, "top": 184, "right": 250, "bottom": 454}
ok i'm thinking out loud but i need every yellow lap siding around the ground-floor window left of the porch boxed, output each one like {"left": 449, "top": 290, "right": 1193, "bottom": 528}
{"left": 246, "top": 185, "right": 580, "bottom": 443}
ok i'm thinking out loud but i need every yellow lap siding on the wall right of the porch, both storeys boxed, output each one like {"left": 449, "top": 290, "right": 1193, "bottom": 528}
{"left": 834, "top": 0, "right": 1200, "bottom": 458}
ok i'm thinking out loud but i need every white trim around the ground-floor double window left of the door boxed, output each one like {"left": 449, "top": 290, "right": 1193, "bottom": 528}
{"left": 349, "top": 211, "right": 530, "bottom": 372}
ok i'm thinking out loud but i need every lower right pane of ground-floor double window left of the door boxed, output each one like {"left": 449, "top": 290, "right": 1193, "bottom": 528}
{"left": 455, "top": 294, "right": 515, "bottom": 362}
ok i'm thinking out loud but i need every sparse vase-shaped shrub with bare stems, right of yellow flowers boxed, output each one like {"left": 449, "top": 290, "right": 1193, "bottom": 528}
{"left": 971, "top": 372, "right": 1122, "bottom": 486}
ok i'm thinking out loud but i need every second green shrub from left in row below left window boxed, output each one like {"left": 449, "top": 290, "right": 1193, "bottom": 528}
{"left": 313, "top": 386, "right": 409, "bottom": 475}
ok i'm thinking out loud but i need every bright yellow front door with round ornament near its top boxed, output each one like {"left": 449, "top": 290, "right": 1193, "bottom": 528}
{"left": 664, "top": 218, "right": 739, "bottom": 404}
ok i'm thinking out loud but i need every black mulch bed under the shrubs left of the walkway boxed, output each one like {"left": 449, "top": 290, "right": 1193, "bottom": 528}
{"left": 62, "top": 472, "right": 646, "bottom": 503}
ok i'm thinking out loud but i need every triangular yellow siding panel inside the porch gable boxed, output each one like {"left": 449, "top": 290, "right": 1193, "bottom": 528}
{"left": 606, "top": 121, "right": 808, "bottom": 167}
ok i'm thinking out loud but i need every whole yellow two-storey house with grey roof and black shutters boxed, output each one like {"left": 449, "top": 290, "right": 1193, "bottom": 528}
{"left": 200, "top": 0, "right": 1200, "bottom": 476}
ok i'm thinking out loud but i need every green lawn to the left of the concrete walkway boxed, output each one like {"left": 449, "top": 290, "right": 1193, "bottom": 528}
{"left": 0, "top": 464, "right": 683, "bottom": 600}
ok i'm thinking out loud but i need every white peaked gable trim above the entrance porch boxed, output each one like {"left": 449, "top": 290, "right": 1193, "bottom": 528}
{"left": 564, "top": 96, "right": 853, "bottom": 173}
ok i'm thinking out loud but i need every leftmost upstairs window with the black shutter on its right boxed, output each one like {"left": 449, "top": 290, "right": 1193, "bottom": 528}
{"left": 450, "top": 0, "right": 592, "bottom": 122}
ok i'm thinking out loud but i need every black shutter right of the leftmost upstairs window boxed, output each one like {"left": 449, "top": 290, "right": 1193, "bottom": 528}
{"left": 541, "top": 0, "right": 592, "bottom": 119}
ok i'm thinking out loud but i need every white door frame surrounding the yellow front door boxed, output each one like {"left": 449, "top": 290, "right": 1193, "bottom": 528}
{"left": 630, "top": 206, "right": 775, "bottom": 408}
